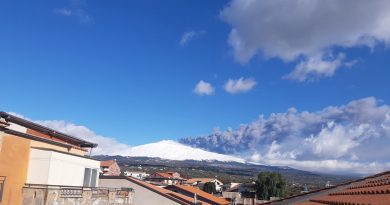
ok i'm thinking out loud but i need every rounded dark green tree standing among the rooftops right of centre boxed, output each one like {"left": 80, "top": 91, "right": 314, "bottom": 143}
{"left": 256, "top": 172, "right": 287, "bottom": 200}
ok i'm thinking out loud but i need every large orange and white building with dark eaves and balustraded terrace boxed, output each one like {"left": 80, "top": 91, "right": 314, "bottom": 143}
{"left": 0, "top": 112, "right": 130, "bottom": 205}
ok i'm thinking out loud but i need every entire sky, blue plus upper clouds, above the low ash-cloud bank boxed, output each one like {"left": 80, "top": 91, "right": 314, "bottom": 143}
{"left": 0, "top": 0, "right": 390, "bottom": 175}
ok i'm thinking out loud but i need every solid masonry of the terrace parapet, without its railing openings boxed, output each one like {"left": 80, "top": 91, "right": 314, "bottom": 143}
{"left": 22, "top": 187, "right": 134, "bottom": 205}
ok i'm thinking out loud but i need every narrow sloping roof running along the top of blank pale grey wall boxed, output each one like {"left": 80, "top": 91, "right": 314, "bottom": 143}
{"left": 100, "top": 176, "right": 211, "bottom": 205}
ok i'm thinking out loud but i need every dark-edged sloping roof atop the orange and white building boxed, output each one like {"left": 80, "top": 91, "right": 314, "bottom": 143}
{"left": 0, "top": 112, "right": 97, "bottom": 148}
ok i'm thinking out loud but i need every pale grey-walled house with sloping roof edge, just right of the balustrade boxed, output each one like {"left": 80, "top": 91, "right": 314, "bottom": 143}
{"left": 99, "top": 176, "right": 210, "bottom": 205}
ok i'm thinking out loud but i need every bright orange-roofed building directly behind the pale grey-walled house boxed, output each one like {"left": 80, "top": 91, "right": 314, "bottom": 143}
{"left": 166, "top": 185, "right": 230, "bottom": 205}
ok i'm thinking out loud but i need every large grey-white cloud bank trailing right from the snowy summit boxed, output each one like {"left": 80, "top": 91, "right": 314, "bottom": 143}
{"left": 180, "top": 97, "right": 390, "bottom": 174}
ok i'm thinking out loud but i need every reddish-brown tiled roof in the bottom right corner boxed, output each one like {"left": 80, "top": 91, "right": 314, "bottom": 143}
{"left": 299, "top": 172, "right": 390, "bottom": 205}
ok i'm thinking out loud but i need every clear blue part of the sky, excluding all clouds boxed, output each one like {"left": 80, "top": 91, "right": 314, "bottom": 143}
{"left": 0, "top": 0, "right": 390, "bottom": 151}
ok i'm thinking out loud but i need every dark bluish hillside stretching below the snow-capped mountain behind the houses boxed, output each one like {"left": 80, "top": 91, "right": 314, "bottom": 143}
{"left": 94, "top": 155, "right": 352, "bottom": 193}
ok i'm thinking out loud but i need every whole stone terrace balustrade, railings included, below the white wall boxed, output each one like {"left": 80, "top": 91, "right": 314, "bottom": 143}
{"left": 22, "top": 186, "right": 134, "bottom": 205}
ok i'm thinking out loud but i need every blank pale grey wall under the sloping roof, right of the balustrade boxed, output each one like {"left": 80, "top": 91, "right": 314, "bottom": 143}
{"left": 99, "top": 179, "right": 180, "bottom": 205}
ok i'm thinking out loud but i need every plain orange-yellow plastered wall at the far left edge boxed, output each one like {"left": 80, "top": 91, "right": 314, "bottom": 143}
{"left": 0, "top": 132, "right": 30, "bottom": 205}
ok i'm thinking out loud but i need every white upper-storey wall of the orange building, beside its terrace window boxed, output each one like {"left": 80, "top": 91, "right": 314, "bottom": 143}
{"left": 26, "top": 148, "right": 100, "bottom": 186}
